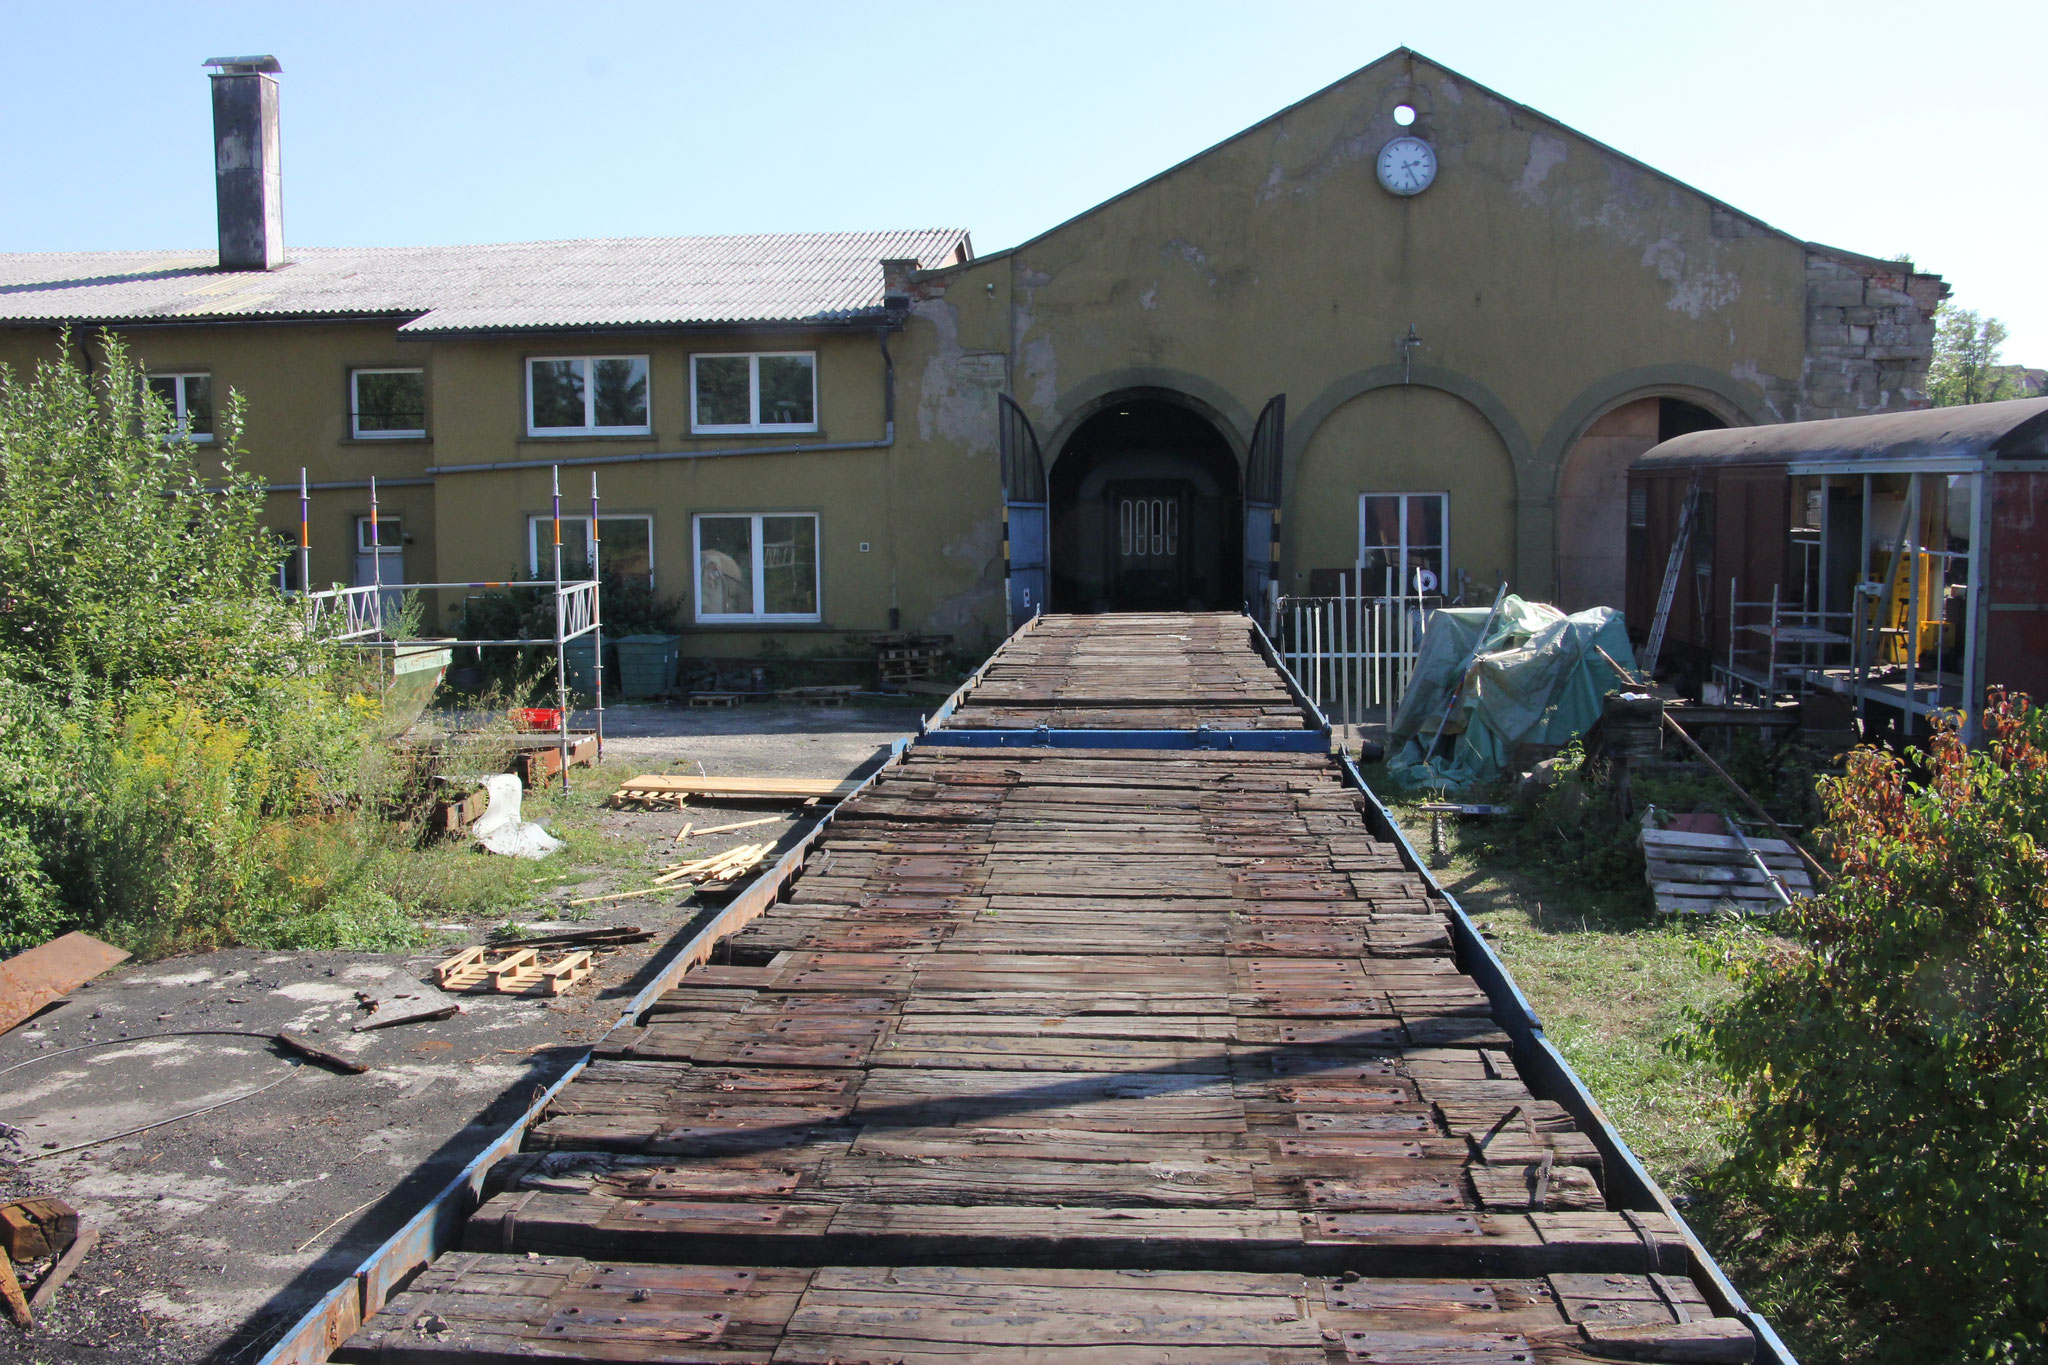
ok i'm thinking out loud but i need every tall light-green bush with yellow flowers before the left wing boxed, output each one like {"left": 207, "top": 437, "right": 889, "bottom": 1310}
{"left": 0, "top": 338, "right": 401, "bottom": 954}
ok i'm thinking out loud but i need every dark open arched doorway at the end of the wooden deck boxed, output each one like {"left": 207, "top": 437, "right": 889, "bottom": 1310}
{"left": 1051, "top": 393, "right": 1243, "bottom": 612}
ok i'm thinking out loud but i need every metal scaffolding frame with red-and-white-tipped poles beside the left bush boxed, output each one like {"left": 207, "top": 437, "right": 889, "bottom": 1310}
{"left": 299, "top": 467, "right": 604, "bottom": 792}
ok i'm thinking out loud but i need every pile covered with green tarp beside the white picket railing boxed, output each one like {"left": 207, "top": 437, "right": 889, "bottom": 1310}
{"left": 1386, "top": 596, "right": 1636, "bottom": 792}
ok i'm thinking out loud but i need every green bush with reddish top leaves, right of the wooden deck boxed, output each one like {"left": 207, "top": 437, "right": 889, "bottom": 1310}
{"left": 1679, "top": 692, "right": 2048, "bottom": 1361}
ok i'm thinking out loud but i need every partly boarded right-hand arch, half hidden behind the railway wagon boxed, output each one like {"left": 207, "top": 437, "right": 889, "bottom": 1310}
{"left": 1556, "top": 395, "right": 1729, "bottom": 612}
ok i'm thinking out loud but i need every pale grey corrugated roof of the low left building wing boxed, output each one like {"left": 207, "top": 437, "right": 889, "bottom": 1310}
{"left": 0, "top": 227, "right": 967, "bottom": 336}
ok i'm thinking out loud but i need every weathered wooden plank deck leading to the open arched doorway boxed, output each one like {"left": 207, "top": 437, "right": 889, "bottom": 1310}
{"left": 336, "top": 618, "right": 1753, "bottom": 1365}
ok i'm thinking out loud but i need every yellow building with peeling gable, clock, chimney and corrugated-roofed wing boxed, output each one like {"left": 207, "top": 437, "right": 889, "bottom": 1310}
{"left": 0, "top": 49, "right": 1946, "bottom": 657}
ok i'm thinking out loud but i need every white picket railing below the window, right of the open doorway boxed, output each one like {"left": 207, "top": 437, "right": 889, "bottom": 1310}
{"left": 1276, "top": 575, "right": 1444, "bottom": 726}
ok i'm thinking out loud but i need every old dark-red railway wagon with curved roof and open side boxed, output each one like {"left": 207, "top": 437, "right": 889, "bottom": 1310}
{"left": 1626, "top": 399, "right": 2048, "bottom": 735}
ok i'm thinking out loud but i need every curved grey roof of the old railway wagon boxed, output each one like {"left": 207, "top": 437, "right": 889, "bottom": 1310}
{"left": 1630, "top": 397, "right": 2048, "bottom": 471}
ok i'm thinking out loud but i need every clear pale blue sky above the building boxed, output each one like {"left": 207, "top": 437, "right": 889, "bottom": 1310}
{"left": 0, "top": 0, "right": 2048, "bottom": 364}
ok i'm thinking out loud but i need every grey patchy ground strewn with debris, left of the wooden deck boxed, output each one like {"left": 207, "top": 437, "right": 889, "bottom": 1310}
{"left": 0, "top": 704, "right": 918, "bottom": 1365}
